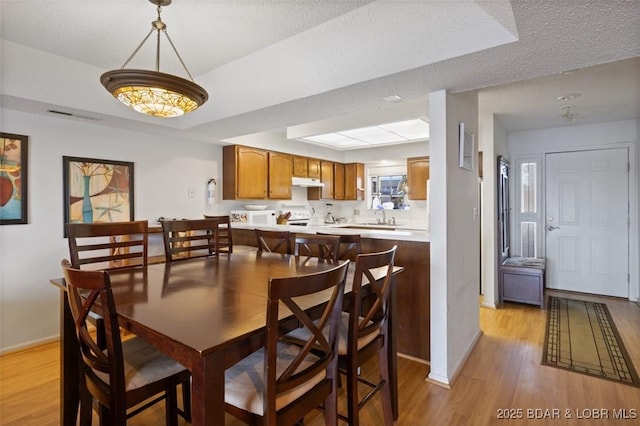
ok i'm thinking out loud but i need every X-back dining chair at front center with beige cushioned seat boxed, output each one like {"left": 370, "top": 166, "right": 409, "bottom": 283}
{"left": 225, "top": 261, "right": 349, "bottom": 425}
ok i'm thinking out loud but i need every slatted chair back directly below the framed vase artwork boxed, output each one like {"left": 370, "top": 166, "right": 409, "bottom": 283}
{"left": 65, "top": 220, "right": 149, "bottom": 269}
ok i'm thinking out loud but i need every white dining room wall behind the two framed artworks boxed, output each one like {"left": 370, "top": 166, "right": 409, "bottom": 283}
{"left": 0, "top": 110, "right": 223, "bottom": 351}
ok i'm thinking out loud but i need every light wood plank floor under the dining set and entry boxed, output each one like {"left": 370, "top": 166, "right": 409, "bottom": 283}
{"left": 0, "top": 288, "right": 640, "bottom": 426}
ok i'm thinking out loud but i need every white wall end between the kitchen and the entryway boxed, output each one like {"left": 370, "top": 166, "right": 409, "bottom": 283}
{"left": 429, "top": 91, "right": 480, "bottom": 385}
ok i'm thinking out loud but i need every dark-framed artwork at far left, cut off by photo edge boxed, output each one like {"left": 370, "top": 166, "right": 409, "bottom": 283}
{"left": 0, "top": 133, "right": 29, "bottom": 225}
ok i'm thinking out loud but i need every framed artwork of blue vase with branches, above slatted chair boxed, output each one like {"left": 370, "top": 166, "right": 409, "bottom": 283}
{"left": 62, "top": 156, "right": 134, "bottom": 231}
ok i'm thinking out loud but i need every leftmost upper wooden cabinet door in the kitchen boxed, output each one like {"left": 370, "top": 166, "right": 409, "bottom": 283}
{"left": 236, "top": 146, "right": 267, "bottom": 199}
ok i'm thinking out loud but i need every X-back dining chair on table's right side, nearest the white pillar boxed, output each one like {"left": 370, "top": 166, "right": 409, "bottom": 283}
{"left": 285, "top": 246, "right": 397, "bottom": 426}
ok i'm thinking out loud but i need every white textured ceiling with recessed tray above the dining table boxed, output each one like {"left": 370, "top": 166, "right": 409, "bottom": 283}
{"left": 0, "top": 0, "right": 640, "bottom": 150}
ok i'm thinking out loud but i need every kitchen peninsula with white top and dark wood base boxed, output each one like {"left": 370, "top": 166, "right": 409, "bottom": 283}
{"left": 232, "top": 223, "right": 430, "bottom": 361}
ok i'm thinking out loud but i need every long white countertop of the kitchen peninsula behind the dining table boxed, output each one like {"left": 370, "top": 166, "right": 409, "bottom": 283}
{"left": 231, "top": 222, "right": 429, "bottom": 242}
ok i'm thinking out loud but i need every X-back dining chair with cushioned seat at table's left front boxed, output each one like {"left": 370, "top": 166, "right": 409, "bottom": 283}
{"left": 62, "top": 259, "right": 191, "bottom": 425}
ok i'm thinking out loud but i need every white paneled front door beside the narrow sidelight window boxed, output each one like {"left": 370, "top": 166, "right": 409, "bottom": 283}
{"left": 545, "top": 148, "right": 629, "bottom": 297}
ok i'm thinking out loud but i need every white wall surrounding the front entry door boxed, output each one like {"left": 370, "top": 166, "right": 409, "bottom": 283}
{"left": 508, "top": 120, "right": 640, "bottom": 300}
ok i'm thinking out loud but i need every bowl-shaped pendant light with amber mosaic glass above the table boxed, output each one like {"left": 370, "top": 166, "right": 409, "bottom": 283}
{"left": 100, "top": 0, "right": 209, "bottom": 117}
